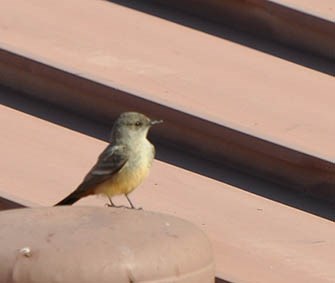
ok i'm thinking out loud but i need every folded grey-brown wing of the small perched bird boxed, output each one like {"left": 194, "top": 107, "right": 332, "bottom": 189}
{"left": 78, "top": 145, "right": 128, "bottom": 194}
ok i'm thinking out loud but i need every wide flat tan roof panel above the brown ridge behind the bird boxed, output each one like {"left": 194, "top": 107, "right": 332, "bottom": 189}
{"left": 0, "top": 0, "right": 335, "bottom": 159}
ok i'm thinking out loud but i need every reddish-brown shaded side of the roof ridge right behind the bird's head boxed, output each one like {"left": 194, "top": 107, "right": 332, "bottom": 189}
{"left": 0, "top": 49, "right": 335, "bottom": 202}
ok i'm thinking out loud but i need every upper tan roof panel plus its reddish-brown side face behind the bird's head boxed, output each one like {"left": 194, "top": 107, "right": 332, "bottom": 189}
{"left": 0, "top": 0, "right": 335, "bottom": 204}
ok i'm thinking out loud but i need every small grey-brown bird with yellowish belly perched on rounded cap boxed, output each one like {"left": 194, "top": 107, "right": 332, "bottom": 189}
{"left": 56, "top": 112, "right": 162, "bottom": 208}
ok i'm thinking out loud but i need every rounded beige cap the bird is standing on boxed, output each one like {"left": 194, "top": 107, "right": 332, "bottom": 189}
{"left": 0, "top": 207, "right": 214, "bottom": 283}
